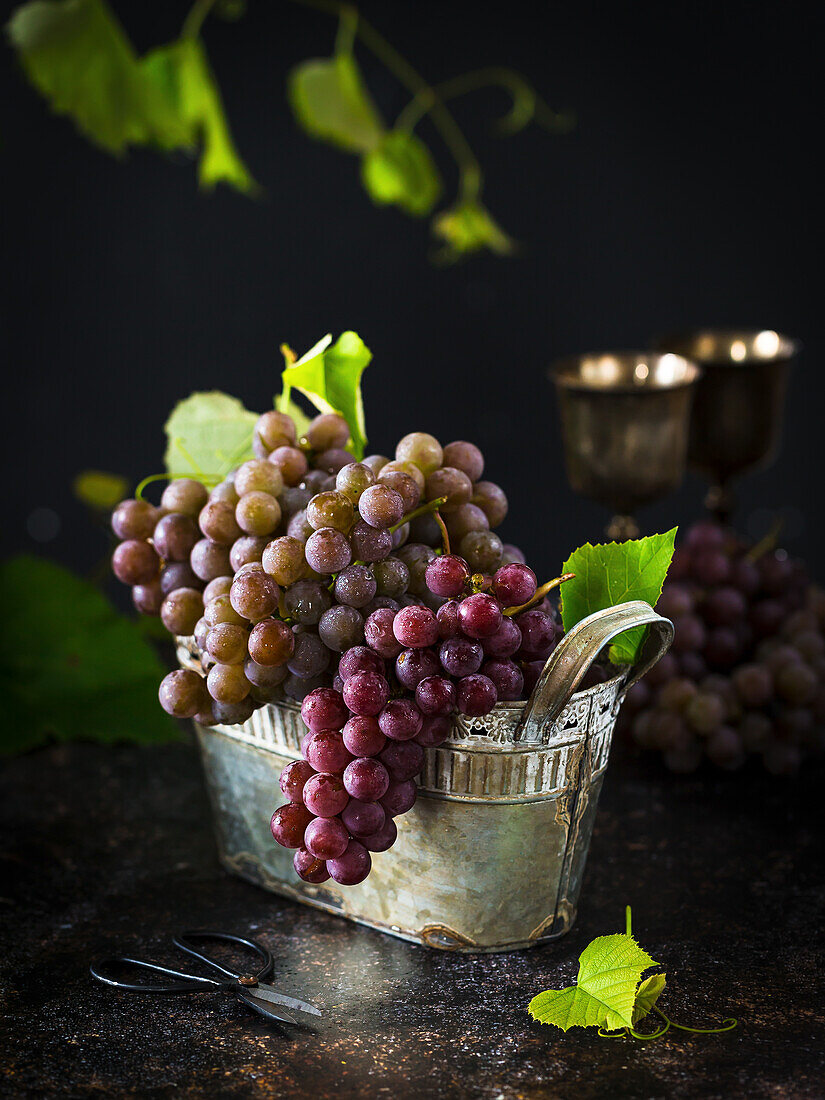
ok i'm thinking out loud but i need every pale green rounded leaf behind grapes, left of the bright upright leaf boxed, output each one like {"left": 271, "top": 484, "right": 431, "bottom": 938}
{"left": 164, "top": 389, "right": 257, "bottom": 480}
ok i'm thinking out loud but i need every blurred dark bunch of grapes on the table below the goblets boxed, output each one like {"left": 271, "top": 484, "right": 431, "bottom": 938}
{"left": 620, "top": 520, "right": 825, "bottom": 776}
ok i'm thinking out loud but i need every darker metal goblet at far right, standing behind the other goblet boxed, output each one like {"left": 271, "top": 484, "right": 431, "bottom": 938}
{"left": 656, "top": 329, "right": 800, "bottom": 521}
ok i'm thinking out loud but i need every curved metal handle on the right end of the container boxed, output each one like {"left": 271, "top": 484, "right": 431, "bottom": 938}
{"left": 513, "top": 600, "right": 673, "bottom": 745}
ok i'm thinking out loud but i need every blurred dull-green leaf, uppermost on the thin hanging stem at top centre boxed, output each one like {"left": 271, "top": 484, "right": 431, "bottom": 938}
{"left": 287, "top": 53, "right": 384, "bottom": 153}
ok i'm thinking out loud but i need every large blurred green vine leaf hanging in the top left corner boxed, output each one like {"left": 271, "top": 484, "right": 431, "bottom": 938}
{"left": 7, "top": 0, "right": 256, "bottom": 193}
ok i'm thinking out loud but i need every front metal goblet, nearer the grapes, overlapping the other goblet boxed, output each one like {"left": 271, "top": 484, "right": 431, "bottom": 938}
{"left": 550, "top": 352, "right": 701, "bottom": 539}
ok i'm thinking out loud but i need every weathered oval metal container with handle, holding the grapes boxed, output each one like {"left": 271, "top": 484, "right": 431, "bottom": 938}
{"left": 180, "top": 602, "right": 673, "bottom": 952}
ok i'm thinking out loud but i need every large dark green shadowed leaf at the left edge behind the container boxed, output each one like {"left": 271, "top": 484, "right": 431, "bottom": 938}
{"left": 0, "top": 557, "right": 177, "bottom": 755}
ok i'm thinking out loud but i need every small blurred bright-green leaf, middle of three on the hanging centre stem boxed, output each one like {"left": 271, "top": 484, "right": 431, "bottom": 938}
{"left": 361, "top": 130, "right": 442, "bottom": 218}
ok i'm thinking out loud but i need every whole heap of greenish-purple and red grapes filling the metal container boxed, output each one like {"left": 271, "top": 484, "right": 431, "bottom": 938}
{"left": 112, "top": 411, "right": 561, "bottom": 886}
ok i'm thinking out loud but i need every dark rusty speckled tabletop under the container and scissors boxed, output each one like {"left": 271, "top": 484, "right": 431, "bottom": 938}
{"left": 0, "top": 744, "right": 825, "bottom": 1100}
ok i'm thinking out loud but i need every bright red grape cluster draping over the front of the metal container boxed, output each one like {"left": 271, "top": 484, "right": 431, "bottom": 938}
{"left": 271, "top": 554, "right": 558, "bottom": 886}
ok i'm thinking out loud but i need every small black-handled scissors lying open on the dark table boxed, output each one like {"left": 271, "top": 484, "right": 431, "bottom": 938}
{"left": 89, "top": 932, "right": 323, "bottom": 1024}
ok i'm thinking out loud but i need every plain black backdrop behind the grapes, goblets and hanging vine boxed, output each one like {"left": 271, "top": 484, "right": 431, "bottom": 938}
{"left": 0, "top": 0, "right": 825, "bottom": 572}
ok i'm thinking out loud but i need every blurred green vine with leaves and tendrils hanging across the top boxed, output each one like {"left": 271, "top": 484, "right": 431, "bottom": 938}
{"left": 7, "top": 0, "right": 572, "bottom": 262}
